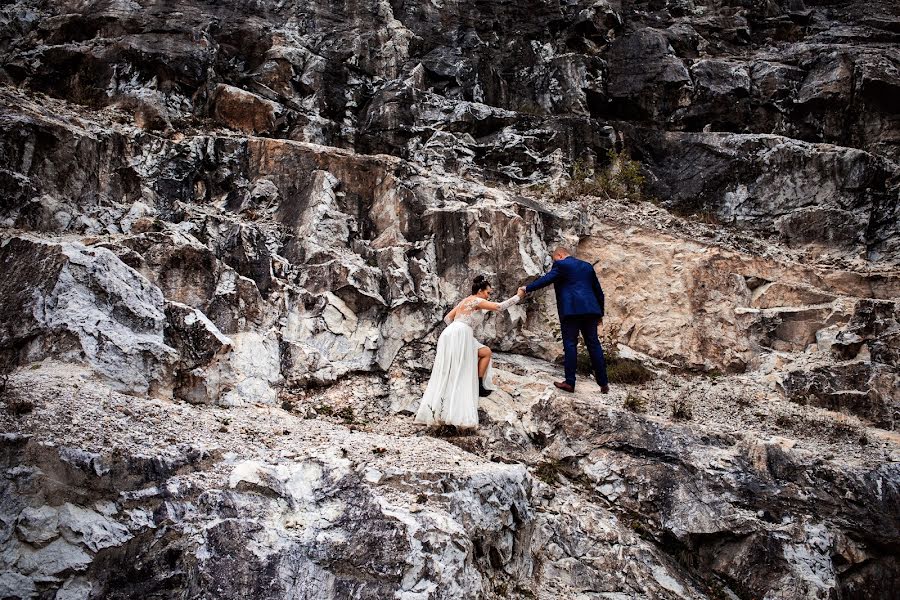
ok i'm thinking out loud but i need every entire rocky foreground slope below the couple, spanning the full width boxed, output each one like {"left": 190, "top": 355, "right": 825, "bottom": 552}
{"left": 2, "top": 356, "right": 900, "bottom": 598}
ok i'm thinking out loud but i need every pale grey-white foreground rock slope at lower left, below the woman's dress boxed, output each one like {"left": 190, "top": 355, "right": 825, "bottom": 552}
{"left": 3, "top": 363, "right": 728, "bottom": 598}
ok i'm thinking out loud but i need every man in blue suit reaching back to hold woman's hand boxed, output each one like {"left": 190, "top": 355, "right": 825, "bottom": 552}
{"left": 519, "top": 247, "right": 609, "bottom": 394}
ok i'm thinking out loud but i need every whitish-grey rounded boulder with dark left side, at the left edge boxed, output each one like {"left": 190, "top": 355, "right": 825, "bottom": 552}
{"left": 0, "top": 237, "right": 175, "bottom": 393}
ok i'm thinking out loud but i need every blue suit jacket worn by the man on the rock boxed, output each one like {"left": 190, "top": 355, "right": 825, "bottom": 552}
{"left": 525, "top": 256, "right": 604, "bottom": 320}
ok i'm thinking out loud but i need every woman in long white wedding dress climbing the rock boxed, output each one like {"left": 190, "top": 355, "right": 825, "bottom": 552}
{"left": 415, "top": 275, "right": 524, "bottom": 427}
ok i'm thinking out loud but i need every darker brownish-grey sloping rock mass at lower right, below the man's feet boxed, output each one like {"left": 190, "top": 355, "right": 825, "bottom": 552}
{"left": 534, "top": 398, "right": 900, "bottom": 598}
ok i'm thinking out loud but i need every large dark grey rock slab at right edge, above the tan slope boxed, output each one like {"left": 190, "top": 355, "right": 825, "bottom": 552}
{"left": 632, "top": 130, "right": 898, "bottom": 259}
